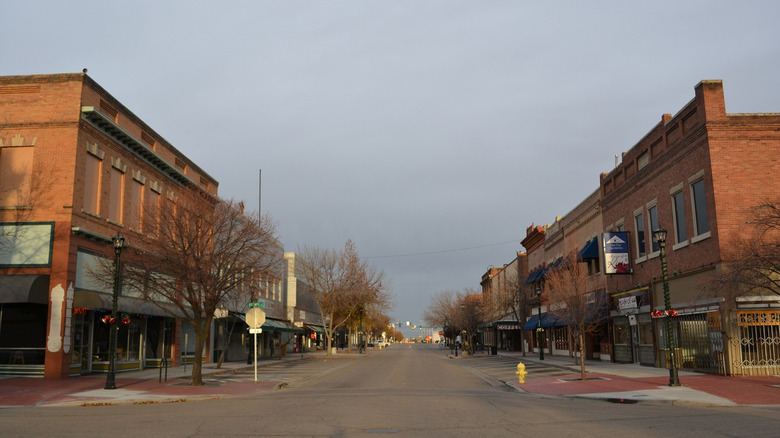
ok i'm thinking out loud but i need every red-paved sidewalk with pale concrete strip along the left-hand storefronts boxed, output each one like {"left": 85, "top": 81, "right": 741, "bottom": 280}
{"left": 0, "top": 352, "right": 332, "bottom": 408}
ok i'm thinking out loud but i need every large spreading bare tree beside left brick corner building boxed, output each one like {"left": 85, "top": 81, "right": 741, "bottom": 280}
{"left": 122, "top": 192, "right": 283, "bottom": 386}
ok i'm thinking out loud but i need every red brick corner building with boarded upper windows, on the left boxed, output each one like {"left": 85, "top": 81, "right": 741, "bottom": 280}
{"left": 0, "top": 73, "right": 218, "bottom": 378}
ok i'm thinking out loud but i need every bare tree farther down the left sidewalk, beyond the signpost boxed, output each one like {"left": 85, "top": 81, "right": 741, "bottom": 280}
{"left": 299, "top": 240, "right": 389, "bottom": 356}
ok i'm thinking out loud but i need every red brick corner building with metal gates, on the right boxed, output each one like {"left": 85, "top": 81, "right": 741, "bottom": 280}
{"left": 600, "top": 81, "right": 780, "bottom": 374}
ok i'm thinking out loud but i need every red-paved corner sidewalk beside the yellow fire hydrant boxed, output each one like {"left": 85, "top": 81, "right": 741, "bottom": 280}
{"left": 499, "top": 352, "right": 780, "bottom": 406}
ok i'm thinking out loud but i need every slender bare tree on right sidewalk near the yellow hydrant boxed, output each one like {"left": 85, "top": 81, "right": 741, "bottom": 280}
{"left": 542, "top": 252, "right": 607, "bottom": 380}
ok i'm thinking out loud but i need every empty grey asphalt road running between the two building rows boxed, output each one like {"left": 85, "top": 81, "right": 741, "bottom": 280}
{"left": 0, "top": 345, "right": 780, "bottom": 438}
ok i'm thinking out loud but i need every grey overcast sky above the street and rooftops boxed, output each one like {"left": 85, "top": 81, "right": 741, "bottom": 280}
{"left": 0, "top": 0, "right": 780, "bottom": 332}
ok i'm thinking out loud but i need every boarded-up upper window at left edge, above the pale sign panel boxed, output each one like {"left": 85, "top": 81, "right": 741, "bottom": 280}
{"left": 0, "top": 147, "right": 33, "bottom": 207}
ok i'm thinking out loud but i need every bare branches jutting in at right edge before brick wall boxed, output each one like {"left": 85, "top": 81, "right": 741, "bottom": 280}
{"left": 711, "top": 202, "right": 780, "bottom": 299}
